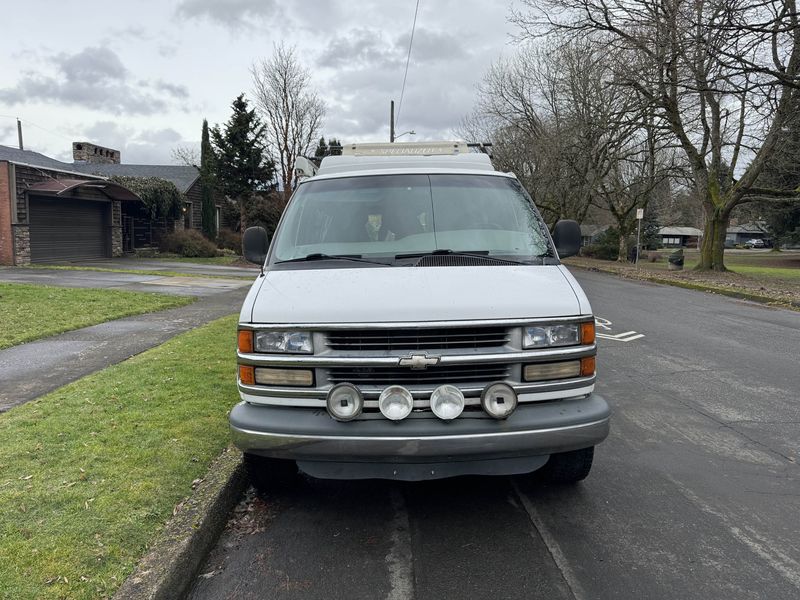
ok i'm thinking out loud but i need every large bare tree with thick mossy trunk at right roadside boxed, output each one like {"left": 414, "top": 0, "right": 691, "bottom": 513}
{"left": 512, "top": 0, "right": 800, "bottom": 271}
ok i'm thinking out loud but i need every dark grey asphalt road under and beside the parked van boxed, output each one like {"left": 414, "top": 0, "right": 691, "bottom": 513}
{"left": 192, "top": 271, "right": 800, "bottom": 600}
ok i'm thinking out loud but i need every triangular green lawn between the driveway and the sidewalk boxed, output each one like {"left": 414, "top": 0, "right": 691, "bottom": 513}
{"left": 0, "top": 283, "right": 193, "bottom": 349}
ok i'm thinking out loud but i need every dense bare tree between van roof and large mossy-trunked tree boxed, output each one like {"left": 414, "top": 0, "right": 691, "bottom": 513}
{"left": 462, "top": 35, "right": 670, "bottom": 260}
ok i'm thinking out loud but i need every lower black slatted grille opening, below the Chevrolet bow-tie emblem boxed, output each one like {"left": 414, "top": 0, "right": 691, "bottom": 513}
{"left": 328, "top": 364, "right": 509, "bottom": 385}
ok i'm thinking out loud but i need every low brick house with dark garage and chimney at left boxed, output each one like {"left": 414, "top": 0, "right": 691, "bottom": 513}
{"left": 0, "top": 142, "right": 219, "bottom": 265}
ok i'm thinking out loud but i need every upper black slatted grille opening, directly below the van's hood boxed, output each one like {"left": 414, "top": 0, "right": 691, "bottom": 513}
{"left": 327, "top": 327, "right": 508, "bottom": 350}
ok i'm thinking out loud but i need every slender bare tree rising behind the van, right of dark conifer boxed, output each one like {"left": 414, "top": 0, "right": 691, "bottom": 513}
{"left": 250, "top": 43, "right": 325, "bottom": 194}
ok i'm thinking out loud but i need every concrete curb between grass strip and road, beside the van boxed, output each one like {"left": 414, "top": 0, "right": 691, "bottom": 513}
{"left": 114, "top": 448, "right": 247, "bottom": 600}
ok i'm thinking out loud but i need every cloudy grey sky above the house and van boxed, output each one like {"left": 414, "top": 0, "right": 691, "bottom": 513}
{"left": 0, "top": 0, "right": 513, "bottom": 163}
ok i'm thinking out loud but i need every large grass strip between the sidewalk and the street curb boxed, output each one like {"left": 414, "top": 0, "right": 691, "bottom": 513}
{"left": 0, "top": 316, "right": 237, "bottom": 600}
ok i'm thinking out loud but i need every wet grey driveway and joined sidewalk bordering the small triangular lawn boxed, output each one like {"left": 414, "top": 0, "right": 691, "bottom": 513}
{"left": 0, "top": 261, "right": 258, "bottom": 412}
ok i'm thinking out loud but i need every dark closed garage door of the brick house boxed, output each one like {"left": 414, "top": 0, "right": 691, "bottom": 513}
{"left": 28, "top": 197, "right": 111, "bottom": 262}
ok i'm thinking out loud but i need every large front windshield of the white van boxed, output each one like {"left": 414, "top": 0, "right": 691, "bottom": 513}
{"left": 270, "top": 175, "right": 554, "bottom": 264}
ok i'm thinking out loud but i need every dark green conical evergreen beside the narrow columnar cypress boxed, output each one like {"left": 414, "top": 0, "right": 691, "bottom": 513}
{"left": 211, "top": 94, "right": 275, "bottom": 231}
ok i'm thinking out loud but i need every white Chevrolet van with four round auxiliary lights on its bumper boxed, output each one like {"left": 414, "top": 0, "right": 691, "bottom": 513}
{"left": 230, "top": 142, "right": 609, "bottom": 487}
